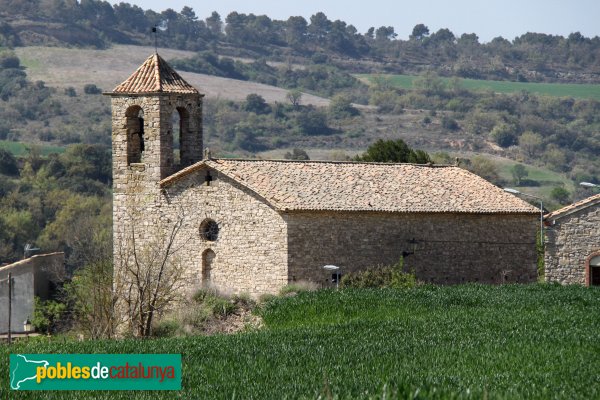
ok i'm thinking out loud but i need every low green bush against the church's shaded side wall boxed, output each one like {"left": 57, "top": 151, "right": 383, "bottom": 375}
{"left": 340, "top": 258, "right": 417, "bottom": 289}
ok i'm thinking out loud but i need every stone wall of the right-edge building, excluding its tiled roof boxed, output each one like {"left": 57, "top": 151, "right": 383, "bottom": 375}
{"left": 545, "top": 205, "right": 600, "bottom": 285}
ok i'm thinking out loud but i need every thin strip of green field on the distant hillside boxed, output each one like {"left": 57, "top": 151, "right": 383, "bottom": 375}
{"left": 356, "top": 74, "right": 600, "bottom": 100}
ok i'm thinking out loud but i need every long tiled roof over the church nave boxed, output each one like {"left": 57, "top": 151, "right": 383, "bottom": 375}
{"left": 160, "top": 159, "right": 539, "bottom": 214}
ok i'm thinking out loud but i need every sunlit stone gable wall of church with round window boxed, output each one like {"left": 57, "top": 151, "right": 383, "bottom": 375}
{"left": 115, "top": 166, "right": 287, "bottom": 295}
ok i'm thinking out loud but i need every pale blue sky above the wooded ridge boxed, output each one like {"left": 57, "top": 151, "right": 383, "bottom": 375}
{"left": 111, "top": 0, "right": 600, "bottom": 42}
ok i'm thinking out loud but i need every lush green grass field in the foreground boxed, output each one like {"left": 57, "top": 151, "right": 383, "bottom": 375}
{"left": 0, "top": 285, "right": 600, "bottom": 399}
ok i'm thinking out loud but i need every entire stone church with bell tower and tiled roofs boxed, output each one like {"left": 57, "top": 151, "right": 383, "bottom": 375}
{"left": 107, "top": 54, "right": 538, "bottom": 295}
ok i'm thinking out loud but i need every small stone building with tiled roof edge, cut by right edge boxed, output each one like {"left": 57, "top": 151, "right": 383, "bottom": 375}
{"left": 545, "top": 194, "right": 600, "bottom": 286}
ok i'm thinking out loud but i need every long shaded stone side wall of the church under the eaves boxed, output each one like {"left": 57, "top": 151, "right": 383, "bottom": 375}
{"left": 285, "top": 212, "right": 538, "bottom": 284}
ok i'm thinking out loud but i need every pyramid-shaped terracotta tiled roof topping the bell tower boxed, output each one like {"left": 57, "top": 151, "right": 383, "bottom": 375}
{"left": 112, "top": 53, "right": 198, "bottom": 94}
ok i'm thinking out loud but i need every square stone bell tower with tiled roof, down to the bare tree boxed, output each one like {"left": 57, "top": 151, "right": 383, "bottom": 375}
{"left": 106, "top": 54, "right": 203, "bottom": 282}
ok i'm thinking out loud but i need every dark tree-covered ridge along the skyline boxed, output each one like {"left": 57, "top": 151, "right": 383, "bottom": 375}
{"left": 0, "top": 0, "right": 600, "bottom": 82}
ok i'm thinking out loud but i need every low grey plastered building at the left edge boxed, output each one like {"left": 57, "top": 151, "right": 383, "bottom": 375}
{"left": 0, "top": 253, "right": 65, "bottom": 333}
